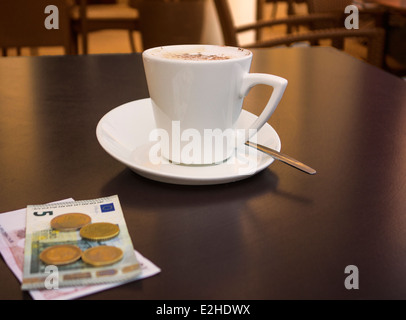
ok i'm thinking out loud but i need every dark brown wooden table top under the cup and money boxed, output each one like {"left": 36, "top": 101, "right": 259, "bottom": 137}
{"left": 0, "top": 48, "right": 406, "bottom": 300}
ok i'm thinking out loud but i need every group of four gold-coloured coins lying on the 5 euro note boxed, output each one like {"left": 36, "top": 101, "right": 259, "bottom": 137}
{"left": 39, "top": 213, "right": 123, "bottom": 267}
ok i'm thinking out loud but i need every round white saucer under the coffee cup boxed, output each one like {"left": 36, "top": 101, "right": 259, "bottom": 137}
{"left": 96, "top": 99, "right": 281, "bottom": 185}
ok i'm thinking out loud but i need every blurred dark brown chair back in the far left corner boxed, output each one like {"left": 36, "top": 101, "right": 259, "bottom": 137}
{"left": 0, "top": 0, "right": 73, "bottom": 56}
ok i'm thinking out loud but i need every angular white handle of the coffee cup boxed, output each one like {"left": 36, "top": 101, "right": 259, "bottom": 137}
{"left": 240, "top": 73, "right": 288, "bottom": 142}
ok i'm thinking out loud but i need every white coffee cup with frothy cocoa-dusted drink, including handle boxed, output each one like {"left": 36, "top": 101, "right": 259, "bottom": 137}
{"left": 143, "top": 45, "right": 287, "bottom": 165}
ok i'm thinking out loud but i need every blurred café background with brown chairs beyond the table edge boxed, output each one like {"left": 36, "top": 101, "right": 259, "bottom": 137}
{"left": 0, "top": 0, "right": 406, "bottom": 76}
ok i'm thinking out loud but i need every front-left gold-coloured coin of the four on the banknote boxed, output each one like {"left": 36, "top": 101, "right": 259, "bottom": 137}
{"left": 39, "top": 244, "right": 82, "bottom": 266}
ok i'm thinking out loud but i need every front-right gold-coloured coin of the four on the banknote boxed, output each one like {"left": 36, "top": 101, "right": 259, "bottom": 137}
{"left": 82, "top": 246, "right": 123, "bottom": 267}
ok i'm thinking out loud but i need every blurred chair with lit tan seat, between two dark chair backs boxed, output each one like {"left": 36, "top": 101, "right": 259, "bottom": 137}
{"left": 70, "top": 0, "right": 139, "bottom": 54}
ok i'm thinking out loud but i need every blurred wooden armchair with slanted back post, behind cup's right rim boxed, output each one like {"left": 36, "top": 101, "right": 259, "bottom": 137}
{"left": 214, "top": 0, "right": 385, "bottom": 67}
